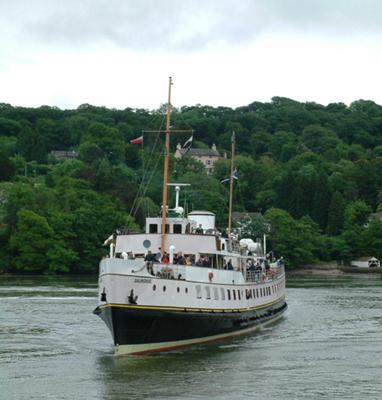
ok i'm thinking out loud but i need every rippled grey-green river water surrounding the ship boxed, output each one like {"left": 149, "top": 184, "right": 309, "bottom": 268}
{"left": 0, "top": 275, "right": 382, "bottom": 400}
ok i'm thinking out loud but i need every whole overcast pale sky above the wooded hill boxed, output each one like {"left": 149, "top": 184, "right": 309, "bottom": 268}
{"left": 0, "top": 0, "right": 382, "bottom": 110}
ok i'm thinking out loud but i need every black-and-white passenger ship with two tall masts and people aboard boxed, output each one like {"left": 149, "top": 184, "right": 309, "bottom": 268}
{"left": 94, "top": 78, "right": 287, "bottom": 355}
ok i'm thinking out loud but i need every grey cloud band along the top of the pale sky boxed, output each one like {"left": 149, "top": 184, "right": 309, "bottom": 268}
{"left": 0, "top": 0, "right": 382, "bottom": 52}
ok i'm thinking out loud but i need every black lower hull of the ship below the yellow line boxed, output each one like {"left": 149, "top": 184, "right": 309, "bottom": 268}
{"left": 95, "top": 299, "right": 287, "bottom": 347}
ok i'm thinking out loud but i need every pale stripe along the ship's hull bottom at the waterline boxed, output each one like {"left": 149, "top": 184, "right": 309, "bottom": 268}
{"left": 115, "top": 314, "right": 283, "bottom": 356}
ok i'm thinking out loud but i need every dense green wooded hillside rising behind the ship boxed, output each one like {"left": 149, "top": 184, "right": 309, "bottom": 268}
{"left": 0, "top": 97, "right": 382, "bottom": 273}
